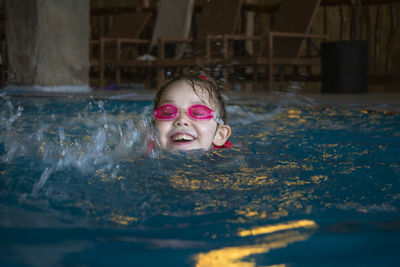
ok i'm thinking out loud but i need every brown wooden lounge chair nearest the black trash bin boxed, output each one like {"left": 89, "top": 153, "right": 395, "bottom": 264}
{"left": 221, "top": 0, "right": 328, "bottom": 90}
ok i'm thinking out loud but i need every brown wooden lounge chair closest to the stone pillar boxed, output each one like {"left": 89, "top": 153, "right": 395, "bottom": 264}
{"left": 90, "top": 11, "right": 152, "bottom": 87}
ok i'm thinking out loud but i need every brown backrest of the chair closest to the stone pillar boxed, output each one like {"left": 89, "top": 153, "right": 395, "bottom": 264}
{"left": 107, "top": 12, "right": 151, "bottom": 38}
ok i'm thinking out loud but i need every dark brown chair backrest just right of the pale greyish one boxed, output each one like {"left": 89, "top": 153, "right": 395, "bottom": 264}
{"left": 195, "top": 0, "right": 243, "bottom": 54}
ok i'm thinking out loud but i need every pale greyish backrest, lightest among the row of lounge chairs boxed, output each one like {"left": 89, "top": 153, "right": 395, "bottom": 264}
{"left": 149, "top": 0, "right": 195, "bottom": 58}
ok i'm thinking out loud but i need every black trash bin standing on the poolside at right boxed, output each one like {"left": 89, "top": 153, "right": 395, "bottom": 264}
{"left": 321, "top": 41, "right": 368, "bottom": 94}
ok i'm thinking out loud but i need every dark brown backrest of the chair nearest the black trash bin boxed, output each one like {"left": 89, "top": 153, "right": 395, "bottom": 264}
{"left": 272, "top": 0, "right": 321, "bottom": 57}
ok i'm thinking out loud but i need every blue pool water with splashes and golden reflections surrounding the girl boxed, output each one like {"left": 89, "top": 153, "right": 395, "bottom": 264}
{"left": 0, "top": 94, "right": 400, "bottom": 266}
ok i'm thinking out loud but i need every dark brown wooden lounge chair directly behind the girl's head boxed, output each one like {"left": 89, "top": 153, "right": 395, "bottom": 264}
{"left": 156, "top": 0, "right": 243, "bottom": 85}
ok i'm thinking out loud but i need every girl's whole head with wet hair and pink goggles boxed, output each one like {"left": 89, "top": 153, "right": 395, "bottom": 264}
{"left": 154, "top": 75, "right": 231, "bottom": 150}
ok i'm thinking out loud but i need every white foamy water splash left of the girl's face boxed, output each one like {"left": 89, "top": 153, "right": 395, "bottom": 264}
{"left": 0, "top": 96, "right": 157, "bottom": 195}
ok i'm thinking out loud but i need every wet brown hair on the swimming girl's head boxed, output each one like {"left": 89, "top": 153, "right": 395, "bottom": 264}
{"left": 154, "top": 74, "right": 226, "bottom": 123}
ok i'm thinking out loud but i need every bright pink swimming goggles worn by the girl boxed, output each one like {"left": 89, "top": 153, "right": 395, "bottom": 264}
{"left": 154, "top": 104, "right": 224, "bottom": 125}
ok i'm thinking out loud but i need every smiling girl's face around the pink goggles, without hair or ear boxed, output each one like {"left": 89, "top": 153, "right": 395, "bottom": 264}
{"left": 155, "top": 81, "right": 222, "bottom": 150}
